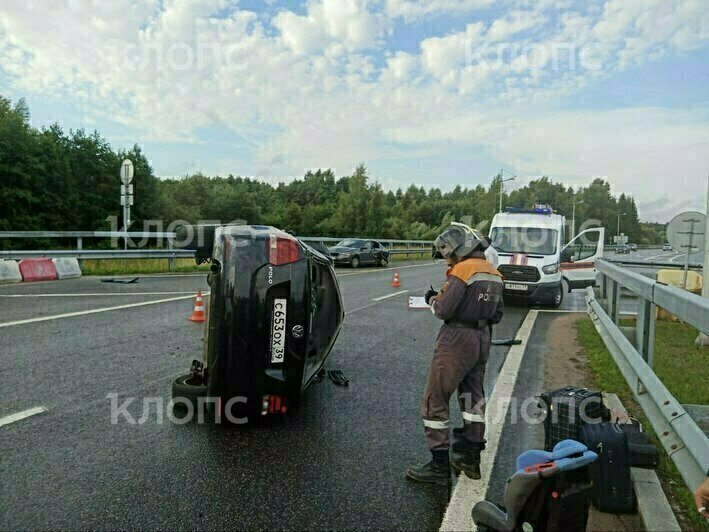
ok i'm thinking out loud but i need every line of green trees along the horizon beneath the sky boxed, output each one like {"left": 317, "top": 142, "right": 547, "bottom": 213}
{"left": 0, "top": 97, "right": 664, "bottom": 247}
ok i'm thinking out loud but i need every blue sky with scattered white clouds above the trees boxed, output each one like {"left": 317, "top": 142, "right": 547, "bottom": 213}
{"left": 0, "top": 0, "right": 709, "bottom": 222}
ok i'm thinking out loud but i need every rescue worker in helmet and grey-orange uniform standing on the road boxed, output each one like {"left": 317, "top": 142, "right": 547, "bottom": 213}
{"left": 406, "top": 226, "right": 503, "bottom": 484}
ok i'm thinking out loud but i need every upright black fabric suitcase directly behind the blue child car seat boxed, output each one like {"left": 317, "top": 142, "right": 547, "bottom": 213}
{"left": 580, "top": 423, "right": 635, "bottom": 514}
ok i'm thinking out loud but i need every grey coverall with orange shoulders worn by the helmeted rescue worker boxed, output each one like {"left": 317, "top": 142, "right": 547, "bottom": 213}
{"left": 421, "top": 252, "right": 504, "bottom": 451}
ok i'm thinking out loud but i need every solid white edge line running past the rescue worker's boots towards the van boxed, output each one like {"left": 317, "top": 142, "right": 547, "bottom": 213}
{"left": 441, "top": 310, "right": 539, "bottom": 530}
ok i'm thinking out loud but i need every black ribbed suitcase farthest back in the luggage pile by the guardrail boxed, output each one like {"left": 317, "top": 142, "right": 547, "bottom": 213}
{"left": 540, "top": 386, "right": 610, "bottom": 451}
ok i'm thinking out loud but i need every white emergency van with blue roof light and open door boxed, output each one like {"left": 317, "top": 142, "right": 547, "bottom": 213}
{"left": 490, "top": 205, "right": 604, "bottom": 307}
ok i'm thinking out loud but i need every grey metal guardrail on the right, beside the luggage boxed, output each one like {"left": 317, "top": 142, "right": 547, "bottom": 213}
{"left": 586, "top": 260, "right": 709, "bottom": 490}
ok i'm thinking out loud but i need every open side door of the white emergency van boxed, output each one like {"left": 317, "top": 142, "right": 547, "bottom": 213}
{"left": 561, "top": 227, "right": 605, "bottom": 291}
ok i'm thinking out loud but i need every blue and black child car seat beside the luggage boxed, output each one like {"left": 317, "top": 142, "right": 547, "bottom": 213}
{"left": 472, "top": 440, "right": 598, "bottom": 532}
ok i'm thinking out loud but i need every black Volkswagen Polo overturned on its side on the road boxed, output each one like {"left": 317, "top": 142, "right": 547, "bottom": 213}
{"left": 172, "top": 225, "right": 344, "bottom": 422}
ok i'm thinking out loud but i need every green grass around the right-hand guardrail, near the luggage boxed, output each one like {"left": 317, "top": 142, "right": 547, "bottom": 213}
{"left": 576, "top": 318, "right": 709, "bottom": 530}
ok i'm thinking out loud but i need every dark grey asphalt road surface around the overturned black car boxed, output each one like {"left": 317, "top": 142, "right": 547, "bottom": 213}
{"left": 0, "top": 252, "right": 668, "bottom": 529}
